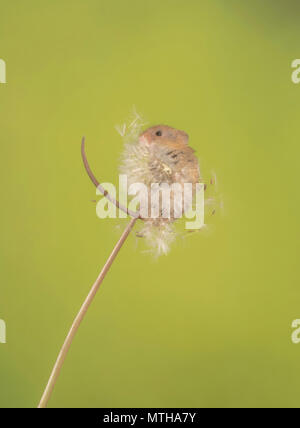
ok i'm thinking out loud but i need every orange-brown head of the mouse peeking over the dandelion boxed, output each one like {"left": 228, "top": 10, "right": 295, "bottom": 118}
{"left": 139, "top": 125, "right": 189, "bottom": 145}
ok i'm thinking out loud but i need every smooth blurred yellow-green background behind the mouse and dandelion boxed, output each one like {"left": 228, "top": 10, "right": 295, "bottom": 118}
{"left": 0, "top": 0, "right": 300, "bottom": 407}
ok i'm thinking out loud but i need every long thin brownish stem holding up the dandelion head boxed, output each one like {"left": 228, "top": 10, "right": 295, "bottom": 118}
{"left": 38, "top": 218, "right": 137, "bottom": 408}
